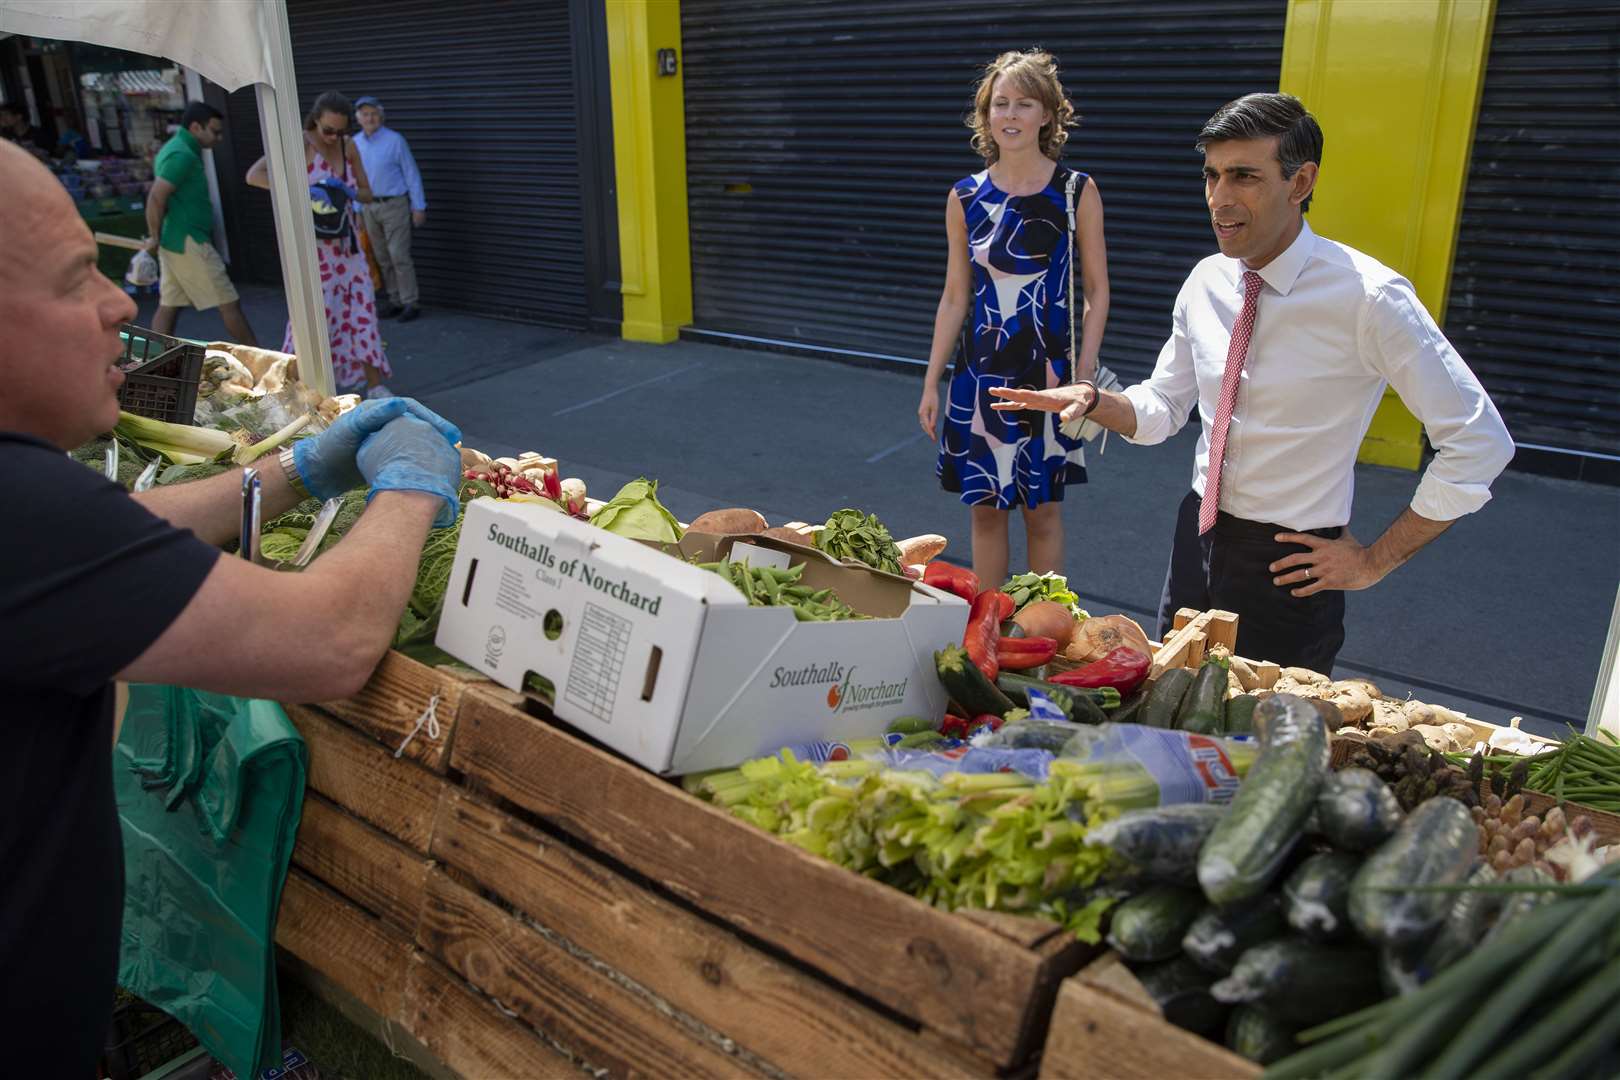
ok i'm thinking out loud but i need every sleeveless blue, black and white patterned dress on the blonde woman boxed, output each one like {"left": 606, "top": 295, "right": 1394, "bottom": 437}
{"left": 935, "top": 167, "right": 1085, "bottom": 510}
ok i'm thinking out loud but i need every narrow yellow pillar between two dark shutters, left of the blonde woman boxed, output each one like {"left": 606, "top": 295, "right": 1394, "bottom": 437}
{"left": 608, "top": 0, "right": 692, "bottom": 342}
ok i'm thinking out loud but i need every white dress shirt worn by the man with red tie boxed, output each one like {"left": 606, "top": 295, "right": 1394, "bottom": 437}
{"left": 1124, "top": 223, "right": 1513, "bottom": 531}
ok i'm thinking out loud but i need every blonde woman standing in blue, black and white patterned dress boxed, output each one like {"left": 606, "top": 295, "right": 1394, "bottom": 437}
{"left": 917, "top": 50, "right": 1108, "bottom": 588}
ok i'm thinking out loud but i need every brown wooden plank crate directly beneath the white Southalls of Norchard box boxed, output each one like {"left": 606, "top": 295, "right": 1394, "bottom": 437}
{"left": 277, "top": 657, "right": 1095, "bottom": 1077}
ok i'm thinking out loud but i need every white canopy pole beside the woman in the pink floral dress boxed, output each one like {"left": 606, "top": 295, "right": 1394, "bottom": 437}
{"left": 254, "top": 0, "right": 328, "bottom": 397}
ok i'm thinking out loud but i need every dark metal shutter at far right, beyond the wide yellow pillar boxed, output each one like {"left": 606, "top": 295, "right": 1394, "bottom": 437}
{"left": 1445, "top": 0, "right": 1620, "bottom": 455}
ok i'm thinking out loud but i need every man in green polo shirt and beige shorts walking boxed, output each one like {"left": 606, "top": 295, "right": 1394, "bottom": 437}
{"left": 146, "top": 102, "right": 259, "bottom": 345}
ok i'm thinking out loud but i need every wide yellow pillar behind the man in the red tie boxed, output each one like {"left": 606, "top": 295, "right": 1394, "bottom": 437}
{"left": 1281, "top": 0, "right": 1495, "bottom": 470}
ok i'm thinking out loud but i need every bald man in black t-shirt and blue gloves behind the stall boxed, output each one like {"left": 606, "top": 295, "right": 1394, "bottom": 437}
{"left": 0, "top": 141, "right": 460, "bottom": 1078}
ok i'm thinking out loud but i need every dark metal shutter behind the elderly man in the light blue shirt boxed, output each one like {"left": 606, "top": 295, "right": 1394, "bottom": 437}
{"left": 218, "top": 0, "right": 592, "bottom": 329}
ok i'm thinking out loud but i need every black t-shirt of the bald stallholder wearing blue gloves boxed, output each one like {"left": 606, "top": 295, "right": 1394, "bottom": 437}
{"left": 0, "top": 432, "right": 219, "bottom": 1077}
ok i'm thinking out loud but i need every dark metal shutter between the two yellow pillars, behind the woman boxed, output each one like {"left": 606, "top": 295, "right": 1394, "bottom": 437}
{"left": 680, "top": 0, "right": 1288, "bottom": 379}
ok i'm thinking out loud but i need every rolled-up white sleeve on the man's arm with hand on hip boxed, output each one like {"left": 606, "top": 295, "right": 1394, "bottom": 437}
{"left": 1361, "top": 279, "right": 1513, "bottom": 521}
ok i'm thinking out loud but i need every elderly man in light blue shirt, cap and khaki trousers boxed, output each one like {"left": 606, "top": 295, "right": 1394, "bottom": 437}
{"left": 355, "top": 96, "right": 428, "bottom": 322}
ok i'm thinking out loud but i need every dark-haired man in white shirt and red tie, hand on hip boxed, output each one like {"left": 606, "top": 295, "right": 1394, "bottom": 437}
{"left": 990, "top": 94, "right": 1513, "bottom": 672}
